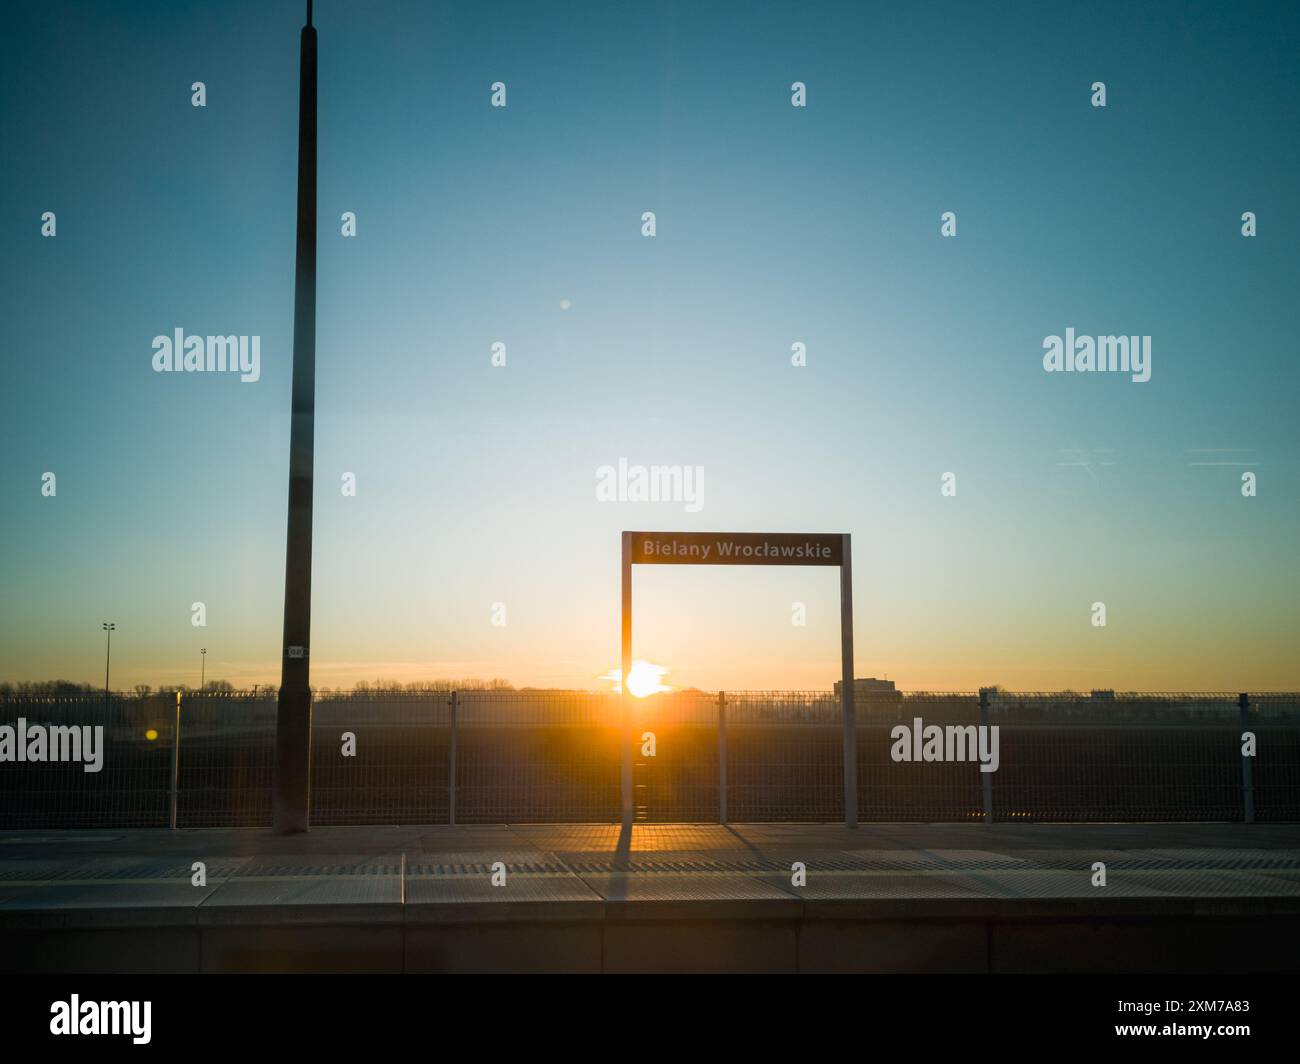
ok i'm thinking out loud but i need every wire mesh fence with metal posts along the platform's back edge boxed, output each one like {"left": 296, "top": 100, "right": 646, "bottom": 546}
{"left": 0, "top": 689, "right": 1300, "bottom": 829}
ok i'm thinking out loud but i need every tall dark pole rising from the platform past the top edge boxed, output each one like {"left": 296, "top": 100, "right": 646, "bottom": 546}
{"left": 272, "top": 0, "right": 316, "bottom": 835}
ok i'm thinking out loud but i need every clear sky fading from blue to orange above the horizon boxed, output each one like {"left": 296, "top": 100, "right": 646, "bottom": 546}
{"left": 0, "top": 0, "right": 1300, "bottom": 692}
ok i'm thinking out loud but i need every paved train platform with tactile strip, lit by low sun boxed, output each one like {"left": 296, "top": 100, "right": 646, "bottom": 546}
{"left": 0, "top": 823, "right": 1300, "bottom": 973}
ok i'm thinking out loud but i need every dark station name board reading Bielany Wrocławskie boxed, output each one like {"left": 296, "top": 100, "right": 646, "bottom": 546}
{"left": 631, "top": 532, "right": 844, "bottom": 566}
